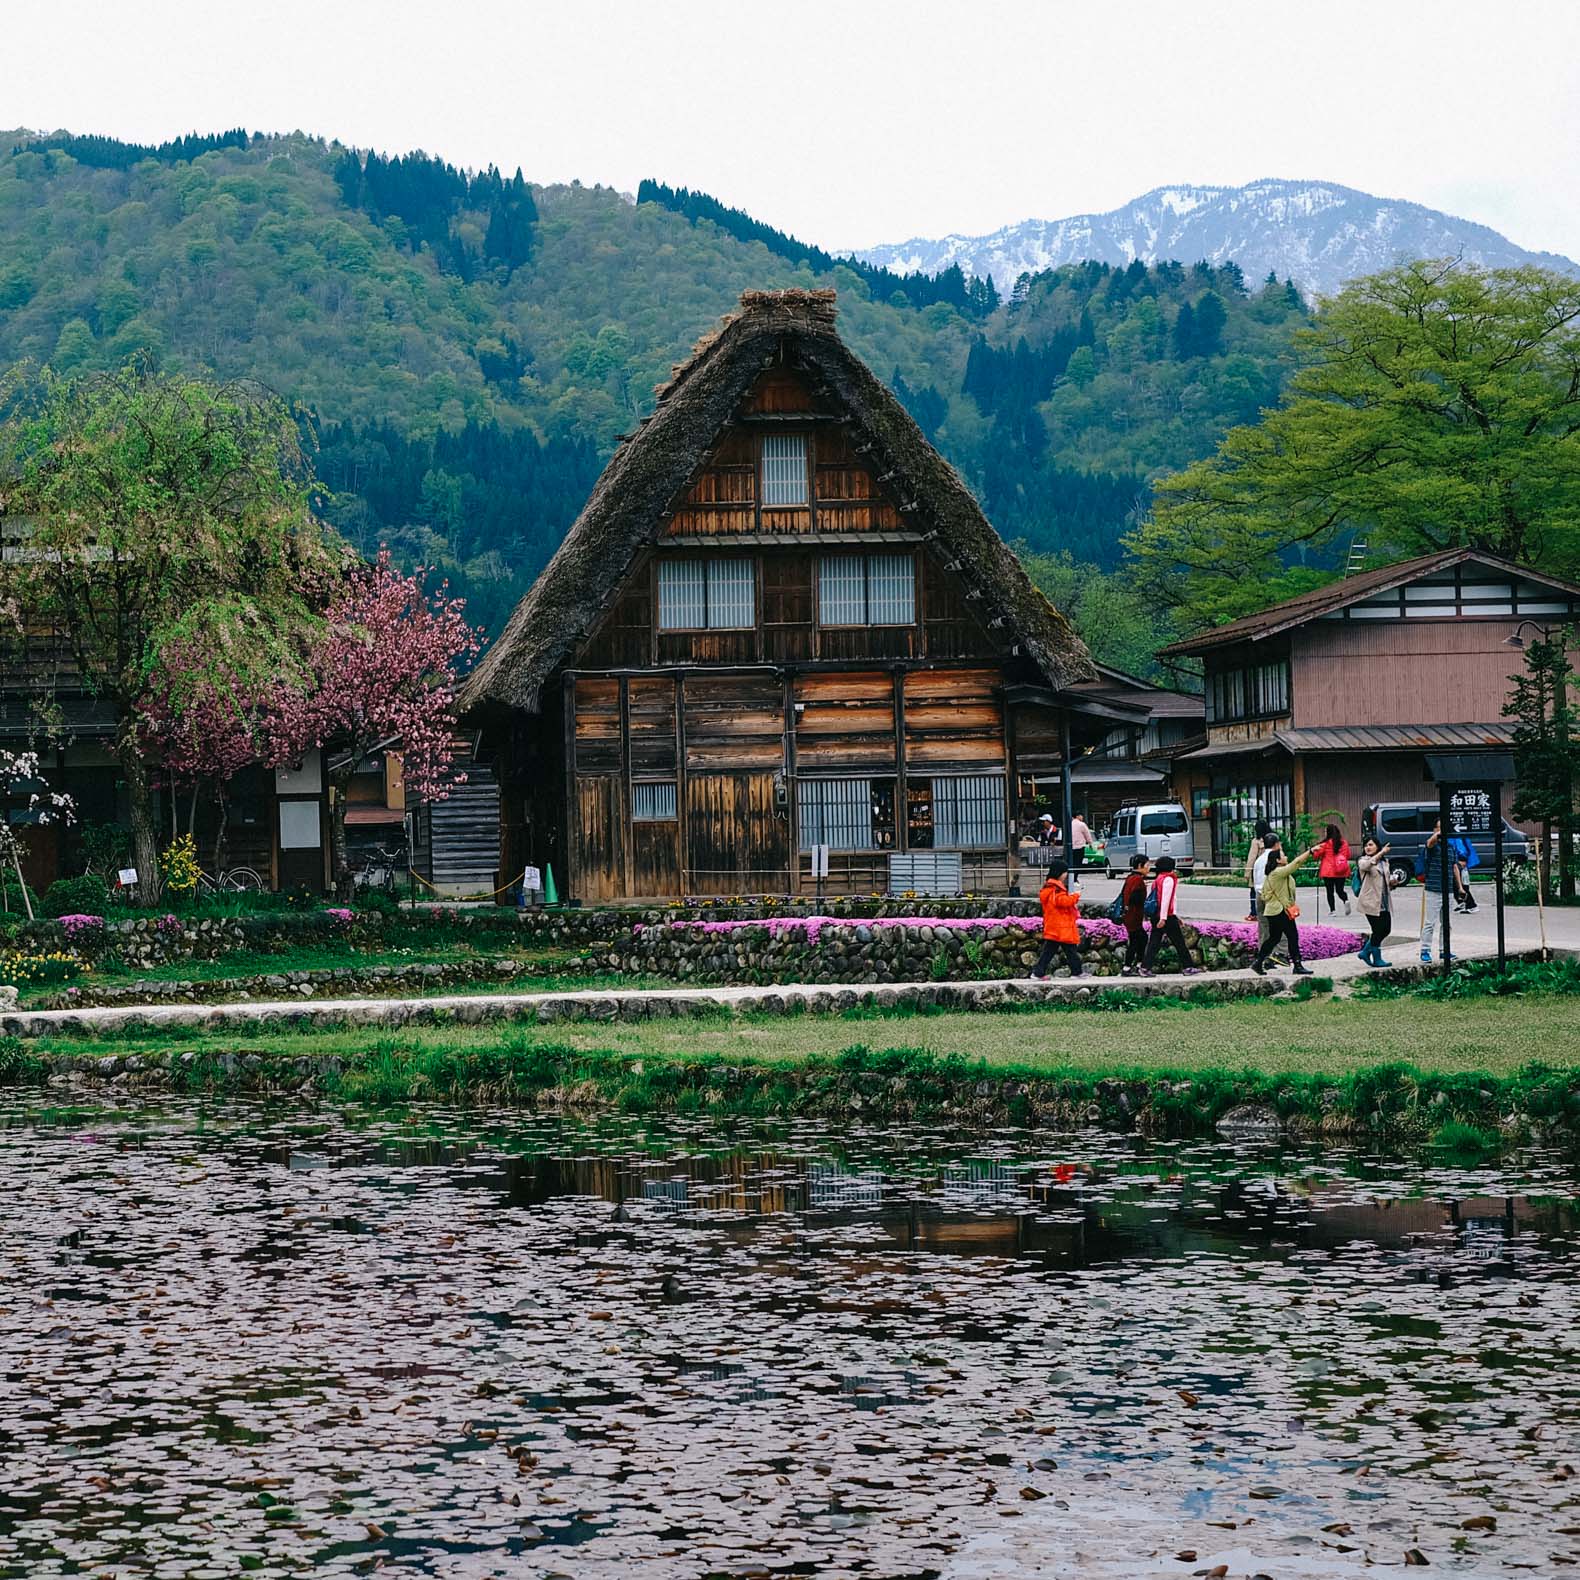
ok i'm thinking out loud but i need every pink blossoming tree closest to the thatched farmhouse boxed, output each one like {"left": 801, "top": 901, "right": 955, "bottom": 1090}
{"left": 267, "top": 550, "right": 482, "bottom": 901}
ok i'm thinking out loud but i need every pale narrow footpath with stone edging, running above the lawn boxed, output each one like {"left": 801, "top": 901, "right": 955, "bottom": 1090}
{"left": 0, "top": 946, "right": 1490, "bottom": 1036}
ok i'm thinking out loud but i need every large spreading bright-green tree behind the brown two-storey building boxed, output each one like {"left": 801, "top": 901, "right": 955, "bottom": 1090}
{"left": 1130, "top": 262, "right": 1580, "bottom": 624}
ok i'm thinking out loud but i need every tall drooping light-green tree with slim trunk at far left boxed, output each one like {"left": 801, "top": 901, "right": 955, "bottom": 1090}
{"left": 0, "top": 367, "right": 338, "bottom": 902}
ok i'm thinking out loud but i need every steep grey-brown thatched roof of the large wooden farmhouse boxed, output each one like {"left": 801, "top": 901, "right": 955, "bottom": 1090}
{"left": 460, "top": 291, "right": 1095, "bottom": 713}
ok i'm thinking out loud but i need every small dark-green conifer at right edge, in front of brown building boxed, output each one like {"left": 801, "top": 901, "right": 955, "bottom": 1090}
{"left": 1503, "top": 630, "right": 1580, "bottom": 901}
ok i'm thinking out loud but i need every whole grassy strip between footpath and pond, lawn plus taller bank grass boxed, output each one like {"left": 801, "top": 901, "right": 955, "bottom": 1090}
{"left": 0, "top": 995, "right": 1580, "bottom": 1141}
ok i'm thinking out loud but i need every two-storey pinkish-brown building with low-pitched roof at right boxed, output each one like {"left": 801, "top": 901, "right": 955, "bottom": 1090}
{"left": 1163, "top": 548, "right": 1580, "bottom": 863}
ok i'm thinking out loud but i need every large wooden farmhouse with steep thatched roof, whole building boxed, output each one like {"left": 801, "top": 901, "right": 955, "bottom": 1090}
{"left": 463, "top": 292, "right": 1111, "bottom": 902}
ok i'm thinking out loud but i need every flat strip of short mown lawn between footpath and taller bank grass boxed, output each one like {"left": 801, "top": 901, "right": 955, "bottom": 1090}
{"left": 21, "top": 994, "right": 1580, "bottom": 1076}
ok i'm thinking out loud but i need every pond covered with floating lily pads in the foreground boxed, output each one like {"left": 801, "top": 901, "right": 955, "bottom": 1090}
{"left": 0, "top": 1101, "right": 1580, "bottom": 1580}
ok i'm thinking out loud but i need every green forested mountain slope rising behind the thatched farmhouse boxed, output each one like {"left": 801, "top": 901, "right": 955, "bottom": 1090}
{"left": 0, "top": 133, "right": 1305, "bottom": 627}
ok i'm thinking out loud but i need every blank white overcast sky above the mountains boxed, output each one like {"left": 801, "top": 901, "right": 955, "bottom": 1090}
{"left": 0, "top": 0, "right": 1580, "bottom": 258}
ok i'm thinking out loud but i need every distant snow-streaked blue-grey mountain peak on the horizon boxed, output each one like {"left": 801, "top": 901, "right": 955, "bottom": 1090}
{"left": 856, "top": 180, "right": 1580, "bottom": 295}
